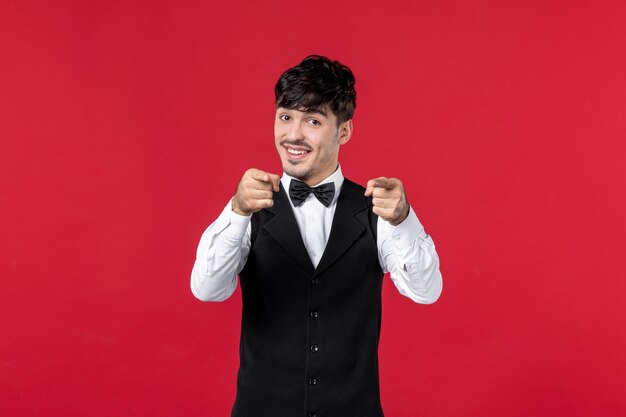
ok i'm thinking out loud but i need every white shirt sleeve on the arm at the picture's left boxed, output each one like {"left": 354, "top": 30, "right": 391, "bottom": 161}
{"left": 191, "top": 200, "right": 250, "bottom": 301}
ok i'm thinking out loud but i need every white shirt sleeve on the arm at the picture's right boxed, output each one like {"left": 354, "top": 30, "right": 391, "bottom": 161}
{"left": 377, "top": 208, "right": 443, "bottom": 304}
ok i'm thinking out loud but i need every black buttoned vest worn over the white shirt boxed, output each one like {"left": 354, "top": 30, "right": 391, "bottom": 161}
{"left": 232, "top": 179, "right": 383, "bottom": 417}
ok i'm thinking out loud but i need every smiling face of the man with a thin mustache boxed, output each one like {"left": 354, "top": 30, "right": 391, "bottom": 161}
{"left": 274, "top": 107, "right": 352, "bottom": 185}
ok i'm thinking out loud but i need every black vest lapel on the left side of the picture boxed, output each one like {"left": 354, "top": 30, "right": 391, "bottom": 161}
{"left": 263, "top": 183, "right": 314, "bottom": 273}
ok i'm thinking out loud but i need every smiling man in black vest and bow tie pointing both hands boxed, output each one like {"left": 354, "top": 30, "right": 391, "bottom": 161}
{"left": 191, "top": 56, "right": 442, "bottom": 417}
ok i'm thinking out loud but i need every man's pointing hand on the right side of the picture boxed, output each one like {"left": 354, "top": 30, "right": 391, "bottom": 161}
{"left": 365, "top": 177, "right": 409, "bottom": 226}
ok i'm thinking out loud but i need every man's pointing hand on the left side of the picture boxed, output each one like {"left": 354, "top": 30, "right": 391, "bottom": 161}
{"left": 233, "top": 168, "right": 280, "bottom": 216}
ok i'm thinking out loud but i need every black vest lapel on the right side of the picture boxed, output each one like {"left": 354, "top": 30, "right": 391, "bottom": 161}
{"left": 314, "top": 179, "right": 367, "bottom": 274}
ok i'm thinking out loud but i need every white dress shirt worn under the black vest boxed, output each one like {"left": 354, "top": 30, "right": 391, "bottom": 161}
{"left": 191, "top": 167, "right": 443, "bottom": 304}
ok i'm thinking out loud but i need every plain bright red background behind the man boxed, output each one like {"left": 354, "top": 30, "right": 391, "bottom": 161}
{"left": 0, "top": 0, "right": 626, "bottom": 417}
